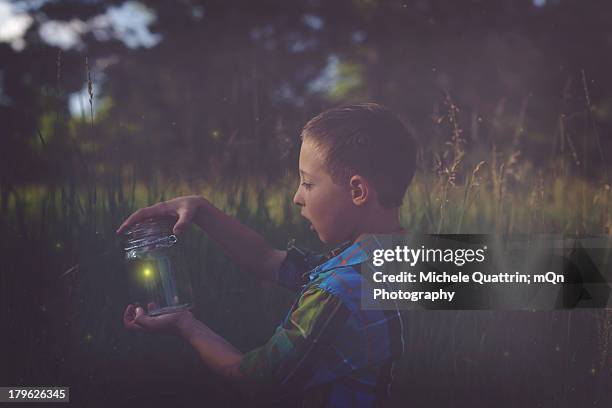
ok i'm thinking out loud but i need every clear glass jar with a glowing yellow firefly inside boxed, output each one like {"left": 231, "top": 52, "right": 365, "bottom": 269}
{"left": 124, "top": 218, "right": 192, "bottom": 316}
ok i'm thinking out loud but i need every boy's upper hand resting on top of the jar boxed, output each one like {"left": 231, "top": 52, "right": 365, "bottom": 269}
{"left": 117, "top": 196, "right": 205, "bottom": 234}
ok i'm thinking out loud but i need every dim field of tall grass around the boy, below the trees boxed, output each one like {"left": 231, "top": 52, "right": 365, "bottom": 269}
{"left": 0, "top": 116, "right": 612, "bottom": 406}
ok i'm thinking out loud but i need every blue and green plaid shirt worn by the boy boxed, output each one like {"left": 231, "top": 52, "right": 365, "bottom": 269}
{"left": 240, "top": 236, "right": 404, "bottom": 407}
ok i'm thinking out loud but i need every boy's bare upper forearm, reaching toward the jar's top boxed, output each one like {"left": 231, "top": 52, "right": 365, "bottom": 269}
{"left": 194, "top": 197, "right": 287, "bottom": 281}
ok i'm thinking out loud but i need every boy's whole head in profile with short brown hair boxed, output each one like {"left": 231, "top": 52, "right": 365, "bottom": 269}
{"left": 294, "top": 103, "right": 416, "bottom": 243}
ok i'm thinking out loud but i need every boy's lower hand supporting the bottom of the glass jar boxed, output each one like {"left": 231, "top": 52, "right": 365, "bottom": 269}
{"left": 123, "top": 305, "right": 195, "bottom": 336}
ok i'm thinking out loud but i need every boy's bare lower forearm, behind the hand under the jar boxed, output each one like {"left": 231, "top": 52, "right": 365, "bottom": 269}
{"left": 178, "top": 318, "right": 242, "bottom": 380}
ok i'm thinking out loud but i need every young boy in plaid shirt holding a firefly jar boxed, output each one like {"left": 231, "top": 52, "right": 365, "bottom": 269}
{"left": 117, "top": 103, "right": 415, "bottom": 407}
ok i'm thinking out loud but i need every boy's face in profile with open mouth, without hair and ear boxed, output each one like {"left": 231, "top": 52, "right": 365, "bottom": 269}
{"left": 293, "top": 137, "right": 357, "bottom": 244}
